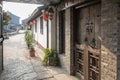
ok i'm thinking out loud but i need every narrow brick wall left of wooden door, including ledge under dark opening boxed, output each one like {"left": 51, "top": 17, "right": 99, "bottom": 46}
{"left": 59, "top": 8, "right": 71, "bottom": 73}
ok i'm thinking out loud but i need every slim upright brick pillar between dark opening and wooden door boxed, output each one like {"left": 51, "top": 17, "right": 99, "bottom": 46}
{"left": 64, "top": 8, "right": 71, "bottom": 74}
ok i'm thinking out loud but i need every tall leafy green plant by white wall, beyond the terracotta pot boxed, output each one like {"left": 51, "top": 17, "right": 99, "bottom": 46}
{"left": 25, "top": 30, "right": 33, "bottom": 48}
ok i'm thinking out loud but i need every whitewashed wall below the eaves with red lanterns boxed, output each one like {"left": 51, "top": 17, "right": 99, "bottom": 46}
{"left": 33, "top": 10, "right": 56, "bottom": 50}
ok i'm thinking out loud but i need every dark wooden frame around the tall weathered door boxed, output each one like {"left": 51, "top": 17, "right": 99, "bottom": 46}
{"left": 70, "top": 0, "right": 101, "bottom": 80}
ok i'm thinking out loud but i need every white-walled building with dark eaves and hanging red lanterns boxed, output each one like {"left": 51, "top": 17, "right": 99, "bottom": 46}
{"left": 28, "top": 6, "right": 56, "bottom": 50}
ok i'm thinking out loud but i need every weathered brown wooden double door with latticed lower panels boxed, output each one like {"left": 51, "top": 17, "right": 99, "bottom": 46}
{"left": 75, "top": 4, "right": 101, "bottom": 80}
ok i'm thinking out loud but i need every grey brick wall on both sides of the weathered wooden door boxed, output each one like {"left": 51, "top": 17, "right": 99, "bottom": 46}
{"left": 58, "top": 0, "right": 120, "bottom": 80}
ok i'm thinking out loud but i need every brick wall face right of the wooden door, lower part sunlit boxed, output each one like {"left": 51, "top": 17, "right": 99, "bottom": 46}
{"left": 101, "top": 0, "right": 119, "bottom": 80}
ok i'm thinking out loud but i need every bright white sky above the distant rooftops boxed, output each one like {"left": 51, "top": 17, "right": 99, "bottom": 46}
{"left": 3, "top": 1, "right": 41, "bottom": 23}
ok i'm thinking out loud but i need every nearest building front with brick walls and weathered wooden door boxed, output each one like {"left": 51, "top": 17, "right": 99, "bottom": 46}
{"left": 56, "top": 0, "right": 120, "bottom": 80}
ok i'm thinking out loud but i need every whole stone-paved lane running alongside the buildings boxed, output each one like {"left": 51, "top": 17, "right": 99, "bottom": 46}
{"left": 0, "top": 34, "right": 79, "bottom": 80}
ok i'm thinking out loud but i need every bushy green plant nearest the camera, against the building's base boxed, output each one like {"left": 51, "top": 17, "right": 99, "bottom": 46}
{"left": 42, "top": 48, "right": 60, "bottom": 66}
